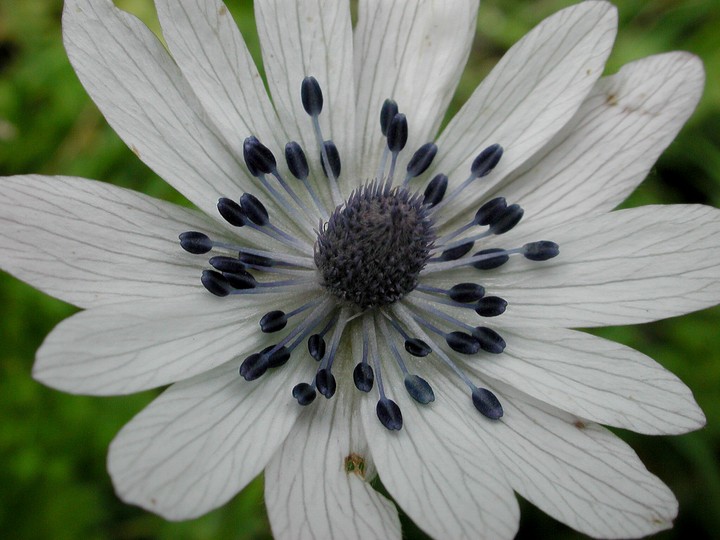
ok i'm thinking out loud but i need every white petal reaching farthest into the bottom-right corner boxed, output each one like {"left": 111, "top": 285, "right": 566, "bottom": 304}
{"left": 480, "top": 389, "right": 677, "bottom": 538}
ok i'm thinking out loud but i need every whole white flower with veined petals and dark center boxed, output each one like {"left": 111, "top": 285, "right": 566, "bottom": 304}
{"left": 0, "top": 0, "right": 720, "bottom": 538}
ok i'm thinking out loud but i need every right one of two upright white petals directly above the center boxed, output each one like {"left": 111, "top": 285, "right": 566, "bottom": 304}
{"left": 355, "top": 0, "right": 479, "bottom": 178}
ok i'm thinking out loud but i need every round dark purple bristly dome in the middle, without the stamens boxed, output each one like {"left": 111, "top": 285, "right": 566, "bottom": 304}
{"left": 315, "top": 182, "right": 435, "bottom": 310}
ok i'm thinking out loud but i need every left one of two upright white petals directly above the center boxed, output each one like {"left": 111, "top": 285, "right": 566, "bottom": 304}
{"left": 254, "top": 0, "right": 357, "bottom": 190}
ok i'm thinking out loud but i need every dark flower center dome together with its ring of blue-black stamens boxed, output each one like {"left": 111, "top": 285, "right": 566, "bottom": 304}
{"left": 180, "top": 77, "right": 559, "bottom": 430}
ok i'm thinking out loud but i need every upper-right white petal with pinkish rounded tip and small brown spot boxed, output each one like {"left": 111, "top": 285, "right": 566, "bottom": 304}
{"left": 496, "top": 52, "right": 705, "bottom": 230}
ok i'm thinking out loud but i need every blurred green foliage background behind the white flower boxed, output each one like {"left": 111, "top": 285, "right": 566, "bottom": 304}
{"left": 0, "top": 0, "right": 720, "bottom": 539}
